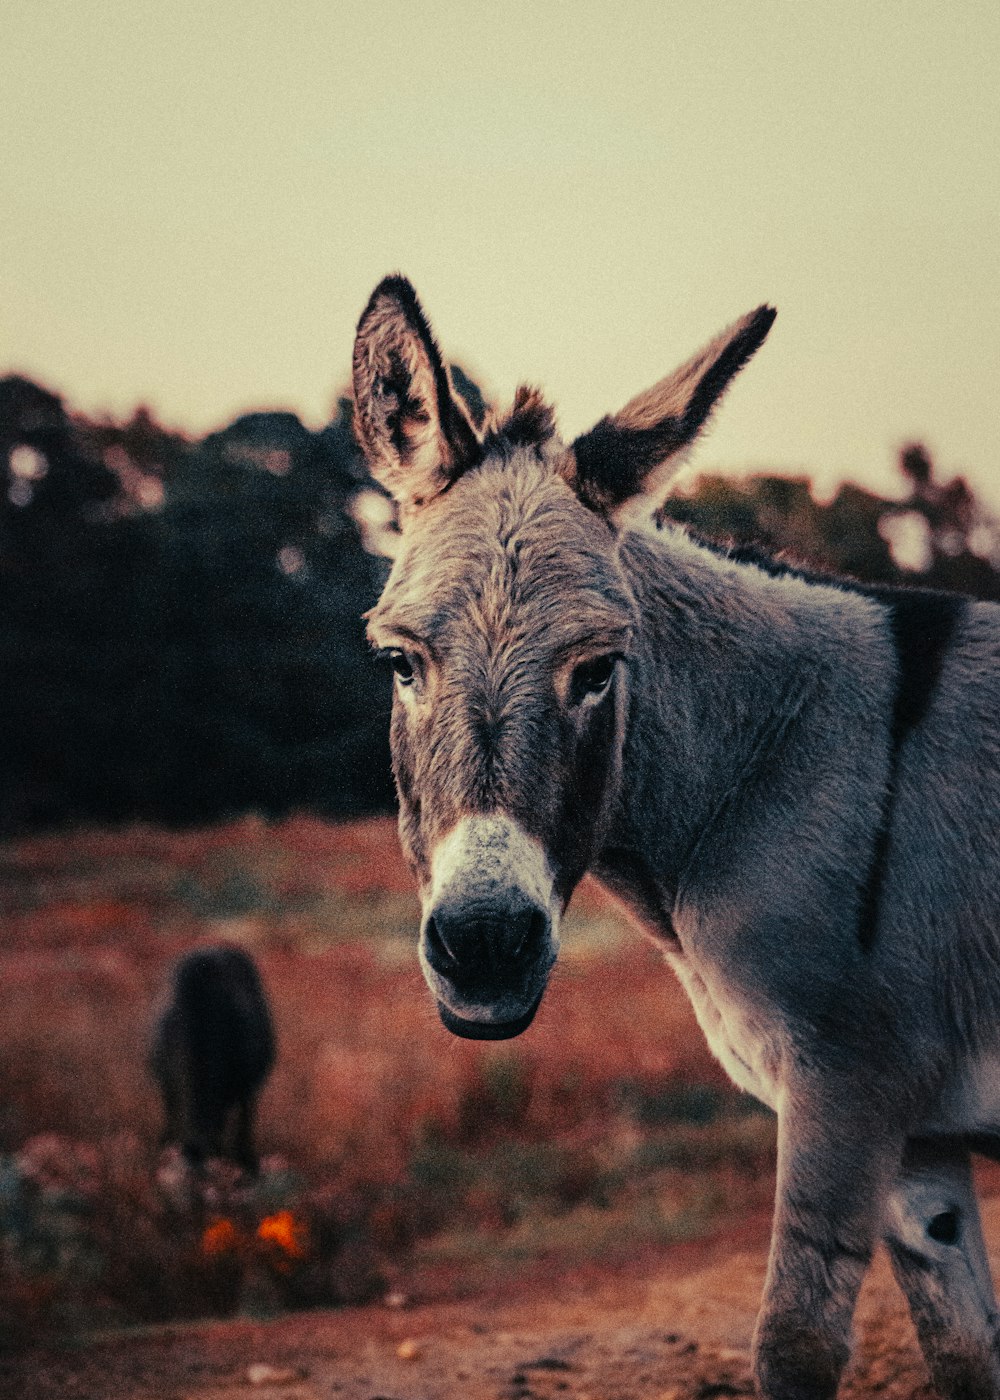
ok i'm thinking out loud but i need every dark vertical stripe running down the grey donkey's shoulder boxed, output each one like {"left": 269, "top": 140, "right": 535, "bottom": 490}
{"left": 857, "top": 588, "right": 968, "bottom": 952}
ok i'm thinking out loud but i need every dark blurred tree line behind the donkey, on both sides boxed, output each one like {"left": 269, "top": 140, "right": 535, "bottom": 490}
{"left": 0, "top": 367, "right": 1000, "bottom": 832}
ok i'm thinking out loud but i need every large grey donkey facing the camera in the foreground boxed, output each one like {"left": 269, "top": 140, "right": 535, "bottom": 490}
{"left": 353, "top": 276, "right": 1000, "bottom": 1400}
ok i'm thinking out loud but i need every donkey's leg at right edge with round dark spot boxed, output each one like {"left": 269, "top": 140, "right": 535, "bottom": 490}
{"left": 885, "top": 1142, "right": 1000, "bottom": 1400}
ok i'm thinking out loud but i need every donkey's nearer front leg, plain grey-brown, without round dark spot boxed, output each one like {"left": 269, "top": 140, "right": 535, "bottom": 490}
{"left": 754, "top": 1077, "right": 902, "bottom": 1400}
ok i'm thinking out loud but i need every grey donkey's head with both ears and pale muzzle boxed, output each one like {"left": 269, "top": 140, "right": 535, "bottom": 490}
{"left": 354, "top": 277, "right": 775, "bottom": 1039}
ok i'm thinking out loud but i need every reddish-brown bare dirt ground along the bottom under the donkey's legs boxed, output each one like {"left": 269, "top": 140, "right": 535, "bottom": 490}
{"left": 9, "top": 1197, "right": 1000, "bottom": 1400}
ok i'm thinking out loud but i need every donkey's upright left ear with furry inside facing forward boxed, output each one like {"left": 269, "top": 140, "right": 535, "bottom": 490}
{"left": 354, "top": 277, "right": 480, "bottom": 517}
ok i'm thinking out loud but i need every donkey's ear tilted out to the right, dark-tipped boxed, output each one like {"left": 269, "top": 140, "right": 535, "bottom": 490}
{"left": 564, "top": 307, "right": 777, "bottom": 517}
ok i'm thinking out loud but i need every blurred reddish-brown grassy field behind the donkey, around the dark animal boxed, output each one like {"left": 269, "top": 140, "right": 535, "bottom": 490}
{"left": 0, "top": 818, "right": 772, "bottom": 1340}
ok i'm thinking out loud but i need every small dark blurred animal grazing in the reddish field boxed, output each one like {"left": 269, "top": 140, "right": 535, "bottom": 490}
{"left": 150, "top": 945, "right": 275, "bottom": 1172}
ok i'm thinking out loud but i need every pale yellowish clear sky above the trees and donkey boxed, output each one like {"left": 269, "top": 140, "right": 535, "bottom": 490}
{"left": 0, "top": 0, "right": 1000, "bottom": 508}
